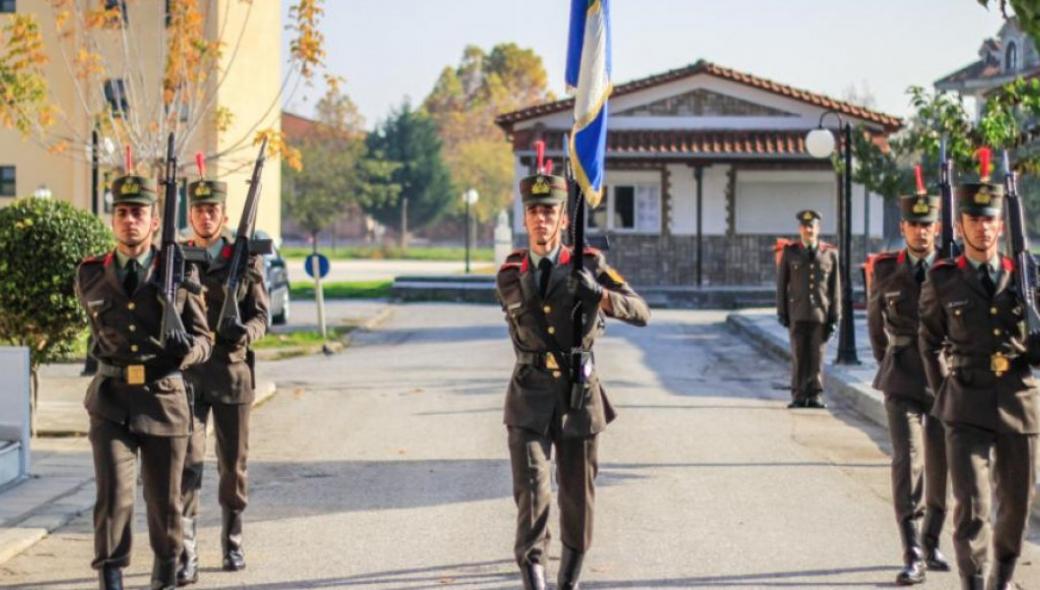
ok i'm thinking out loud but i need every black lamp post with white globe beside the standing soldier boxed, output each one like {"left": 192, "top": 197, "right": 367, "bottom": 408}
{"left": 805, "top": 110, "right": 859, "bottom": 364}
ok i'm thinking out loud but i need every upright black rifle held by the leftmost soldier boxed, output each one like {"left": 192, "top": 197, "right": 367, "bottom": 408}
{"left": 158, "top": 133, "right": 202, "bottom": 348}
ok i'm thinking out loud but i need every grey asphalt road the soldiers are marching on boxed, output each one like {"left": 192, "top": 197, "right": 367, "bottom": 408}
{"left": 0, "top": 305, "right": 1040, "bottom": 590}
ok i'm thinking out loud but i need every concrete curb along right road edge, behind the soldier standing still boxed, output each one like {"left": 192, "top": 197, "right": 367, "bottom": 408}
{"left": 726, "top": 313, "right": 888, "bottom": 428}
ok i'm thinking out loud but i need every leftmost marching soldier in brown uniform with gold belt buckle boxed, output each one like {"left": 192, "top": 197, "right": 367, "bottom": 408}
{"left": 76, "top": 176, "right": 212, "bottom": 590}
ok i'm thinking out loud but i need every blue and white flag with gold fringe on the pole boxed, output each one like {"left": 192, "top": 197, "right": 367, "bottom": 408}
{"left": 567, "top": 0, "right": 614, "bottom": 207}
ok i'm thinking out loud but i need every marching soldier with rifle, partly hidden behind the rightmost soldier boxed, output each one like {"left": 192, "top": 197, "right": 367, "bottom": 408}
{"left": 867, "top": 186, "right": 950, "bottom": 586}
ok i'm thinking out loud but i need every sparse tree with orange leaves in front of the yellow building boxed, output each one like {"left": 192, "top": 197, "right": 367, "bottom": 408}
{"left": 0, "top": 0, "right": 324, "bottom": 174}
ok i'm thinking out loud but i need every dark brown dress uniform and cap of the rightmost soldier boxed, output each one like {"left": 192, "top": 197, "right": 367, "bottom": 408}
{"left": 919, "top": 182, "right": 1040, "bottom": 590}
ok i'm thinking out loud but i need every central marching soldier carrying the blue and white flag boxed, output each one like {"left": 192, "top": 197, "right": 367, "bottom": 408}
{"left": 497, "top": 174, "right": 650, "bottom": 589}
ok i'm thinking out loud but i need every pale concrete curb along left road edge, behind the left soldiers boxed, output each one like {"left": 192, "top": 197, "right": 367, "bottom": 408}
{"left": 0, "top": 381, "right": 278, "bottom": 564}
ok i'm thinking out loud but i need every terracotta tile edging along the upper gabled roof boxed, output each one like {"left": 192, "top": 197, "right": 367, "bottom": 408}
{"left": 495, "top": 59, "right": 903, "bottom": 131}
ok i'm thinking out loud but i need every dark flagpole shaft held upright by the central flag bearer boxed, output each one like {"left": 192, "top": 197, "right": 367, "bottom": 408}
{"left": 564, "top": 134, "right": 592, "bottom": 410}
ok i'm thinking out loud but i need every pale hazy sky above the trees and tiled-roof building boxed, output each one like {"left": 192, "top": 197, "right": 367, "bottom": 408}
{"left": 283, "top": 0, "right": 1003, "bottom": 127}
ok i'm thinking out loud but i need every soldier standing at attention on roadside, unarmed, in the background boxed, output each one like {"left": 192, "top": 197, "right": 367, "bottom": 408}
{"left": 777, "top": 210, "right": 841, "bottom": 408}
